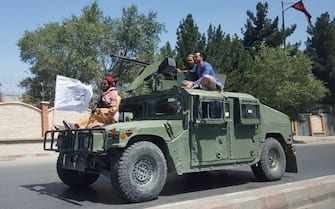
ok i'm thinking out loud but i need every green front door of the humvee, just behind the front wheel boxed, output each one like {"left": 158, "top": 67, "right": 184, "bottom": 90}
{"left": 190, "top": 96, "right": 229, "bottom": 166}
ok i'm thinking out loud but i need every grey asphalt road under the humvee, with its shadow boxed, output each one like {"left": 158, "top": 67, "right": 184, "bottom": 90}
{"left": 0, "top": 144, "right": 335, "bottom": 209}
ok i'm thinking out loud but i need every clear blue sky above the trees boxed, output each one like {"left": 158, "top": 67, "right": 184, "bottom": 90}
{"left": 0, "top": 0, "right": 335, "bottom": 97}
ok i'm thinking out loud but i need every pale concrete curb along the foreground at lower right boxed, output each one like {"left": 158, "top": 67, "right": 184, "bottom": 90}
{"left": 146, "top": 175, "right": 335, "bottom": 209}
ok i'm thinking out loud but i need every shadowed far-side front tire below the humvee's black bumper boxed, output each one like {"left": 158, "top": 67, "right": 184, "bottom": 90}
{"left": 57, "top": 154, "right": 99, "bottom": 188}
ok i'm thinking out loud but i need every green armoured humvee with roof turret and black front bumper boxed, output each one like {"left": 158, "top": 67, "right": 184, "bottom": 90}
{"left": 44, "top": 56, "right": 297, "bottom": 202}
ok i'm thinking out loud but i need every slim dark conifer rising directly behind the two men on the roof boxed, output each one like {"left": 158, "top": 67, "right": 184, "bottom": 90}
{"left": 176, "top": 14, "right": 203, "bottom": 66}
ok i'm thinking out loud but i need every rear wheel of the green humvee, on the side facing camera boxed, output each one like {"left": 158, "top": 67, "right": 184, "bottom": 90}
{"left": 251, "top": 138, "right": 286, "bottom": 181}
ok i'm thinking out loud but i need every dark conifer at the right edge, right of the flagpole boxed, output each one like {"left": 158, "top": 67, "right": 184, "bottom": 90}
{"left": 306, "top": 12, "right": 335, "bottom": 106}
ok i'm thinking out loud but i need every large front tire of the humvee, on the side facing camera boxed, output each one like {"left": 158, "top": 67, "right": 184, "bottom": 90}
{"left": 111, "top": 141, "right": 167, "bottom": 202}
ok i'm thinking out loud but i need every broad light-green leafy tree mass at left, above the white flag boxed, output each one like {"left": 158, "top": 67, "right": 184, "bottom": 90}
{"left": 18, "top": 2, "right": 164, "bottom": 101}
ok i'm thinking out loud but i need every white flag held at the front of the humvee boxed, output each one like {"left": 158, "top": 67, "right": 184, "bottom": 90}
{"left": 55, "top": 75, "right": 93, "bottom": 112}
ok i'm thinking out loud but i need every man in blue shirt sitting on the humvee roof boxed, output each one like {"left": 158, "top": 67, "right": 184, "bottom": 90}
{"left": 183, "top": 52, "right": 224, "bottom": 91}
